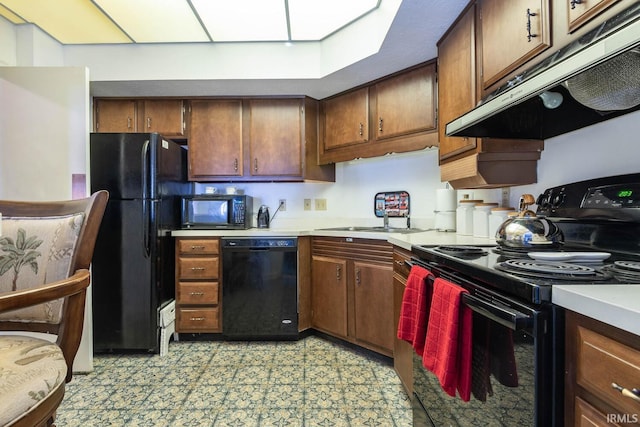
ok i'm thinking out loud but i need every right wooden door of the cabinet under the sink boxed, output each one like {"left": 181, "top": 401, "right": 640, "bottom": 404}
{"left": 353, "top": 261, "right": 395, "bottom": 351}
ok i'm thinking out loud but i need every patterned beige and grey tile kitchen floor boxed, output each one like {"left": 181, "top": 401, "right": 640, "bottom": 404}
{"left": 57, "top": 335, "right": 412, "bottom": 427}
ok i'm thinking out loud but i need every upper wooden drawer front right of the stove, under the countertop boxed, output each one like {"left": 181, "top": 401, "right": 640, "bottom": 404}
{"left": 576, "top": 326, "right": 640, "bottom": 414}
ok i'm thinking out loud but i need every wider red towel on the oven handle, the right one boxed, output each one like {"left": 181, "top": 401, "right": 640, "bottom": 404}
{"left": 422, "top": 278, "right": 472, "bottom": 402}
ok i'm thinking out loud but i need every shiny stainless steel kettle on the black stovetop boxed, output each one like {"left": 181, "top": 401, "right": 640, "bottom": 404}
{"left": 496, "top": 194, "right": 564, "bottom": 250}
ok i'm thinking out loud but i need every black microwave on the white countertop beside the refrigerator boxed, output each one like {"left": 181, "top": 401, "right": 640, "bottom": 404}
{"left": 182, "top": 194, "right": 253, "bottom": 230}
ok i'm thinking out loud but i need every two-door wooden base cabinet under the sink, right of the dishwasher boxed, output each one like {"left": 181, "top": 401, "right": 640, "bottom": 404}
{"left": 311, "top": 237, "right": 395, "bottom": 356}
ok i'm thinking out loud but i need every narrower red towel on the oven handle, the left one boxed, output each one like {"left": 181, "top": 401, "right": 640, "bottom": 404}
{"left": 398, "top": 265, "right": 431, "bottom": 356}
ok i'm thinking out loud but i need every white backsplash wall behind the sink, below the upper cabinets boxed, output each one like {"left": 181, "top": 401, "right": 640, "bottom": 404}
{"left": 196, "top": 149, "right": 501, "bottom": 228}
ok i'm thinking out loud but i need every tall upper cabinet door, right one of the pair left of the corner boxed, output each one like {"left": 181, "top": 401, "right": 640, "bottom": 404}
{"left": 249, "top": 99, "right": 303, "bottom": 177}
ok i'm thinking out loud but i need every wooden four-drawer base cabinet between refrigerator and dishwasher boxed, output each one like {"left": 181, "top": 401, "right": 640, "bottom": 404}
{"left": 176, "top": 237, "right": 222, "bottom": 333}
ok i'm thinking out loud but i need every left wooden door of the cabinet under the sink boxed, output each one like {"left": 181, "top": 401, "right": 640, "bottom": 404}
{"left": 311, "top": 256, "right": 347, "bottom": 337}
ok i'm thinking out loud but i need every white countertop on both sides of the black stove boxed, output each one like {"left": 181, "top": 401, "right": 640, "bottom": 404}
{"left": 171, "top": 228, "right": 640, "bottom": 335}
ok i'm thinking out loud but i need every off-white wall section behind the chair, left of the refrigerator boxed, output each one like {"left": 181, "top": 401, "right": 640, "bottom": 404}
{"left": 0, "top": 67, "right": 89, "bottom": 200}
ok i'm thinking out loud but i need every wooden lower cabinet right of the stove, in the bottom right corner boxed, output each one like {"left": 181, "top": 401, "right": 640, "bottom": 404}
{"left": 565, "top": 311, "right": 640, "bottom": 427}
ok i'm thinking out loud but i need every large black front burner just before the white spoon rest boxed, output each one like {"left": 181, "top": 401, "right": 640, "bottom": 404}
{"left": 495, "top": 258, "right": 613, "bottom": 281}
